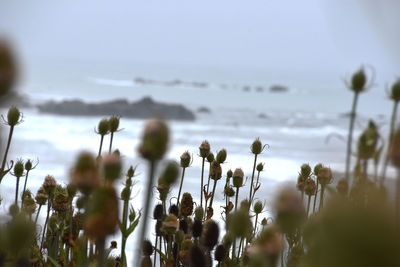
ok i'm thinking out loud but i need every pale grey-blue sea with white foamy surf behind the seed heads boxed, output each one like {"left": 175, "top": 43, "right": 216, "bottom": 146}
{"left": 0, "top": 62, "right": 392, "bottom": 264}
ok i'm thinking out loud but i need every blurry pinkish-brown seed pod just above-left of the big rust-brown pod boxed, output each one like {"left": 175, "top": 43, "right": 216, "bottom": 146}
{"left": 71, "top": 152, "right": 100, "bottom": 195}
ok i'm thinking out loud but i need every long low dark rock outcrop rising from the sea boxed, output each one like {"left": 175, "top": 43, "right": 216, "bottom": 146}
{"left": 37, "top": 97, "right": 195, "bottom": 121}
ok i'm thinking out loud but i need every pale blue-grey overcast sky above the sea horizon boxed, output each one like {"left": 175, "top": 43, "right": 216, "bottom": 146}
{"left": 0, "top": 0, "right": 400, "bottom": 75}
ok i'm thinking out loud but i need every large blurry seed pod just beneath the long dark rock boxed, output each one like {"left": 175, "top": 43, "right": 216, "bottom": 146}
{"left": 139, "top": 119, "right": 169, "bottom": 161}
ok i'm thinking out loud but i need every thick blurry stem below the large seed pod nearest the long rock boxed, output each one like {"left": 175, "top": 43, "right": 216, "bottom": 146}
{"left": 133, "top": 161, "right": 156, "bottom": 266}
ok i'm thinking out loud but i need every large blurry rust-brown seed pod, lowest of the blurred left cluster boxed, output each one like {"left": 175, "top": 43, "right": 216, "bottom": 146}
{"left": 84, "top": 186, "right": 119, "bottom": 240}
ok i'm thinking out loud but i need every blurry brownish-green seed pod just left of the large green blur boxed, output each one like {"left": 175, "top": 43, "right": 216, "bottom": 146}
{"left": 274, "top": 188, "right": 306, "bottom": 233}
